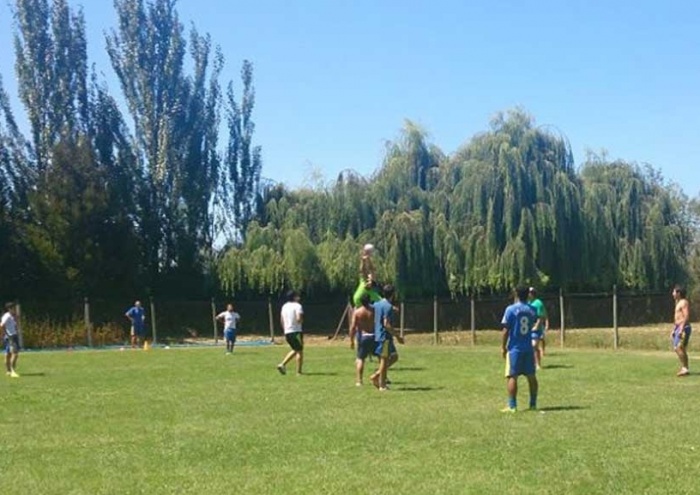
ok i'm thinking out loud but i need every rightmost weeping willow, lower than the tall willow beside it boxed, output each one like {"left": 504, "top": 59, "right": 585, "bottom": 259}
{"left": 581, "top": 155, "right": 690, "bottom": 289}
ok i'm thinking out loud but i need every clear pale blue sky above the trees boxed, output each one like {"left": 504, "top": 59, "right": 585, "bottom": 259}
{"left": 0, "top": 0, "right": 700, "bottom": 196}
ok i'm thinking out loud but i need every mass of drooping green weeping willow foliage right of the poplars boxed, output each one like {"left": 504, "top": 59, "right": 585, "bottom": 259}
{"left": 220, "top": 110, "right": 695, "bottom": 297}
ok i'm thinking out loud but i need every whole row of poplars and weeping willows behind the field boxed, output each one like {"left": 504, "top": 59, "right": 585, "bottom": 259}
{"left": 0, "top": 0, "right": 700, "bottom": 298}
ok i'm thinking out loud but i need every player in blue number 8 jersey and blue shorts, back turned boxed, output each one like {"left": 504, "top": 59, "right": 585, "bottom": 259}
{"left": 501, "top": 287, "right": 537, "bottom": 412}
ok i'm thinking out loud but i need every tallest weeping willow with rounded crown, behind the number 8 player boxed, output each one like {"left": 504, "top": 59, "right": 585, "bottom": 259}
{"left": 438, "top": 110, "right": 584, "bottom": 290}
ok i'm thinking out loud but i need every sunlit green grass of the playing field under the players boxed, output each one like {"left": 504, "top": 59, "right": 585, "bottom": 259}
{"left": 0, "top": 344, "right": 700, "bottom": 495}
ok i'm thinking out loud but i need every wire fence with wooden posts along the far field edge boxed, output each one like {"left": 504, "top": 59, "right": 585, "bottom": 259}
{"left": 9, "top": 290, "right": 692, "bottom": 348}
